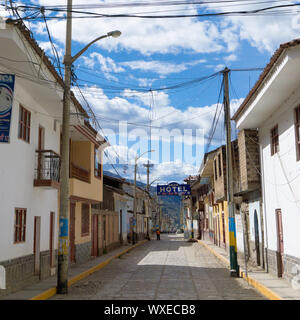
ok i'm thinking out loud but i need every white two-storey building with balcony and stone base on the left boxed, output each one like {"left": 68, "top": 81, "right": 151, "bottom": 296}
{"left": 0, "top": 21, "right": 84, "bottom": 295}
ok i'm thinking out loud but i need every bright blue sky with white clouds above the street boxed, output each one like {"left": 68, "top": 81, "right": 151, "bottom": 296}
{"left": 0, "top": 0, "right": 300, "bottom": 186}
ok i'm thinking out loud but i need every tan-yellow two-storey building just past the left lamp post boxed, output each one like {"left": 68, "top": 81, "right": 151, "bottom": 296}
{"left": 69, "top": 122, "right": 107, "bottom": 263}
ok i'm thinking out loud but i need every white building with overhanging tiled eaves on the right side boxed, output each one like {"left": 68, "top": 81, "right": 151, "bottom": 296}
{"left": 234, "top": 40, "right": 300, "bottom": 280}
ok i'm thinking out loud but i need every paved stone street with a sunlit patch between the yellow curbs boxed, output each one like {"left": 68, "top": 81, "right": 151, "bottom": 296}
{"left": 52, "top": 234, "right": 264, "bottom": 300}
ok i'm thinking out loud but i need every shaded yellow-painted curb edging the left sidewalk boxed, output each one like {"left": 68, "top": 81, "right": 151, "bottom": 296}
{"left": 29, "top": 240, "right": 148, "bottom": 300}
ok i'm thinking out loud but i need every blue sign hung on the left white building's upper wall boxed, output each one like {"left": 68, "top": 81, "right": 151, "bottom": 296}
{"left": 0, "top": 74, "right": 15, "bottom": 143}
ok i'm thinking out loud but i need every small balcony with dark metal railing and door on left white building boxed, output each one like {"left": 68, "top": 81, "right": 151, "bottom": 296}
{"left": 34, "top": 150, "right": 60, "bottom": 189}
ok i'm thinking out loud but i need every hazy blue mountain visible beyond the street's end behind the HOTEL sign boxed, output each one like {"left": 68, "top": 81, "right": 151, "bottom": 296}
{"left": 103, "top": 171, "right": 181, "bottom": 225}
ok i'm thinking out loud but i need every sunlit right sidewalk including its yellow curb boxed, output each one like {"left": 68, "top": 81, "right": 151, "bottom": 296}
{"left": 198, "top": 240, "right": 300, "bottom": 300}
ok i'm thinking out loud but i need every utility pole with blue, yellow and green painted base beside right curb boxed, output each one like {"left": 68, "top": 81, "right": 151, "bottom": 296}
{"left": 223, "top": 67, "right": 239, "bottom": 277}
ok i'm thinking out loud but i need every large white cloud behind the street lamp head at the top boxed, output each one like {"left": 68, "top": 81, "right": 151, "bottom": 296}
{"left": 30, "top": 0, "right": 237, "bottom": 55}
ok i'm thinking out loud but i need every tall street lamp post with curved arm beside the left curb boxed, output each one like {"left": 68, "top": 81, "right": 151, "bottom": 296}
{"left": 57, "top": 0, "right": 121, "bottom": 294}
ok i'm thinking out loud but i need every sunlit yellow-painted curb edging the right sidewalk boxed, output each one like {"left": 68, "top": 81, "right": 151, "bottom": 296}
{"left": 198, "top": 240, "right": 284, "bottom": 300}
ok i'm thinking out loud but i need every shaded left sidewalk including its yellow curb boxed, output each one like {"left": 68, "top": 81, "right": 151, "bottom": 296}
{"left": 0, "top": 240, "right": 148, "bottom": 300}
